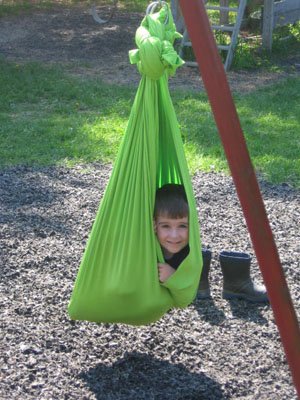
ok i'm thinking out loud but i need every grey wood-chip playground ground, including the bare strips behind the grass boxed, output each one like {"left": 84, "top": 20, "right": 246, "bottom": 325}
{"left": 0, "top": 3, "right": 300, "bottom": 400}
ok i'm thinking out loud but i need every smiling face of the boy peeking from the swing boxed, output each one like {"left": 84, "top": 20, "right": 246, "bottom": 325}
{"left": 154, "top": 215, "right": 189, "bottom": 257}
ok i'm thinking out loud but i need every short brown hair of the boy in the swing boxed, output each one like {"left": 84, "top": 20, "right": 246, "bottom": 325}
{"left": 154, "top": 183, "right": 189, "bottom": 219}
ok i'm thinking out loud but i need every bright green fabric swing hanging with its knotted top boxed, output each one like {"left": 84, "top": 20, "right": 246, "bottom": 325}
{"left": 68, "top": 7, "right": 202, "bottom": 325}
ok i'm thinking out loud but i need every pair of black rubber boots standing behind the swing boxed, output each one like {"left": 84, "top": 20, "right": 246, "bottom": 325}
{"left": 198, "top": 249, "right": 269, "bottom": 303}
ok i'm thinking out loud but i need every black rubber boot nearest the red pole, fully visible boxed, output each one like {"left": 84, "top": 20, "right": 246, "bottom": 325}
{"left": 219, "top": 251, "right": 269, "bottom": 303}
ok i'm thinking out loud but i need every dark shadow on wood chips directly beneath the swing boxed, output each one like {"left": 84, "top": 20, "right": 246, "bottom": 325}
{"left": 80, "top": 352, "right": 228, "bottom": 400}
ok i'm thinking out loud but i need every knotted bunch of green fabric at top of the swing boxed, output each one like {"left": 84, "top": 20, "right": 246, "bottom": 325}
{"left": 129, "top": 6, "right": 184, "bottom": 80}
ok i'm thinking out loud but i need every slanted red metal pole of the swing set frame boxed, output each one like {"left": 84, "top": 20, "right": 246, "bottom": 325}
{"left": 179, "top": 0, "right": 300, "bottom": 398}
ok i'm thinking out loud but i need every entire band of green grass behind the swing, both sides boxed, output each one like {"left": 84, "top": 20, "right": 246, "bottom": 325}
{"left": 0, "top": 60, "right": 300, "bottom": 187}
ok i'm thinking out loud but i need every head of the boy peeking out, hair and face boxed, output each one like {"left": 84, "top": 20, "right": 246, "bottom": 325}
{"left": 154, "top": 184, "right": 189, "bottom": 258}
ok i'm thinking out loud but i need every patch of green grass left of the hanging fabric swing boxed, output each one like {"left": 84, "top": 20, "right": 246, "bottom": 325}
{"left": 0, "top": 62, "right": 131, "bottom": 165}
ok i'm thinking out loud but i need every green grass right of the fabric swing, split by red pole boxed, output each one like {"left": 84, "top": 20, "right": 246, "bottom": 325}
{"left": 173, "top": 78, "right": 300, "bottom": 187}
